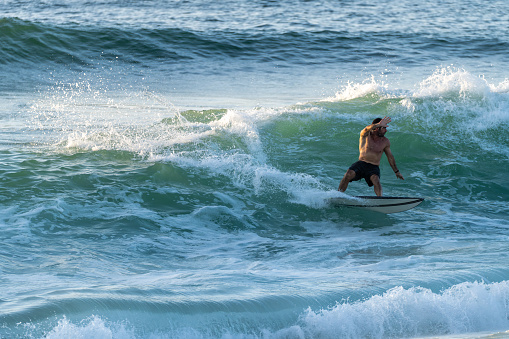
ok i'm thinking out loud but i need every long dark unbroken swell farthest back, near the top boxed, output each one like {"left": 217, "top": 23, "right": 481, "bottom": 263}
{"left": 0, "top": 18, "right": 509, "bottom": 66}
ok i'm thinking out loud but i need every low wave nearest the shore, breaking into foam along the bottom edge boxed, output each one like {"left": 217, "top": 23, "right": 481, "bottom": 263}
{"left": 6, "top": 282, "right": 509, "bottom": 339}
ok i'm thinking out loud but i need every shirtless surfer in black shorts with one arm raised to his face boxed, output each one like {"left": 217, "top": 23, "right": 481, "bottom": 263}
{"left": 338, "top": 117, "right": 405, "bottom": 197}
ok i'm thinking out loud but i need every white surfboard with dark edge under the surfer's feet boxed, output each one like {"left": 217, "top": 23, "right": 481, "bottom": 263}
{"left": 330, "top": 196, "right": 424, "bottom": 214}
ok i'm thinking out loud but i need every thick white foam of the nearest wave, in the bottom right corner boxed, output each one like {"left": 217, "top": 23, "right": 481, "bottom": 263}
{"left": 302, "top": 281, "right": 509, "bottom": 338}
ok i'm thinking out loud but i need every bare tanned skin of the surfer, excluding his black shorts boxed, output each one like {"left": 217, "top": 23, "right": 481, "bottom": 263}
{"left": 338, "top": 117, "right": 405, "bottom": 197}
